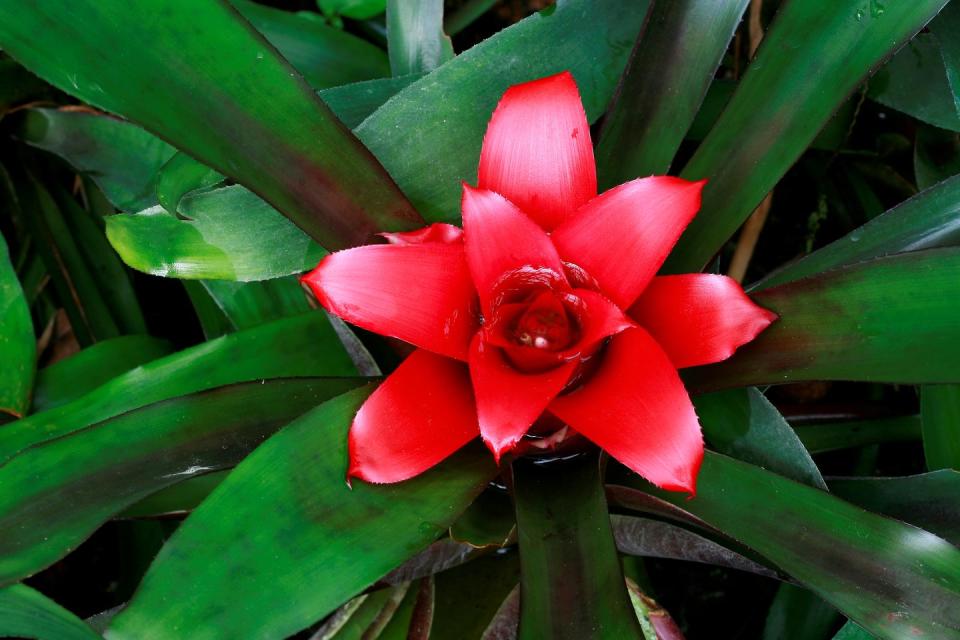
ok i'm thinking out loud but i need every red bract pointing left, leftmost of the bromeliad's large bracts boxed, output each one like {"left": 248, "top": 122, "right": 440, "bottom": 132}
{"left": 302, "top": 242, "right": 478, "bottom": 360}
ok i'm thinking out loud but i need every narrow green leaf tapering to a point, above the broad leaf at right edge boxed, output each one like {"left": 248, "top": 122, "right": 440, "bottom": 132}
{"left": 750, "top": 176, "right": 960, "bottom": 291}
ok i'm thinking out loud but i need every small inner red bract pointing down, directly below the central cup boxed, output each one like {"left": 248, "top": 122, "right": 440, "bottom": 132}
{"left": 470, "top": 335, "right": 576, "bottom": 460}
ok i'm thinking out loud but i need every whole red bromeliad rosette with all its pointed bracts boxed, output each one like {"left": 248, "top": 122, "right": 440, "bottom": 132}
{"left": 304, "top": 73, "right": 776, "bottom": 493}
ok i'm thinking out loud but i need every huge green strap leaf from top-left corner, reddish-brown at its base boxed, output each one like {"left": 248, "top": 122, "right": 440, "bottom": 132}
{"left": 0, "top": 0, "right": 419, "bottom": 249}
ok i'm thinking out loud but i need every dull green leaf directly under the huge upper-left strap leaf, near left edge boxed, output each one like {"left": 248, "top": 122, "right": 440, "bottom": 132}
{"left": 15, "top": 109, "right": 176, "bottom": 211}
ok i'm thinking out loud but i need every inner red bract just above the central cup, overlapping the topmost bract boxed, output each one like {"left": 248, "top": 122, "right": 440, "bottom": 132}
{"left": 463, "top": 184, "right": 563, "bottom": 313}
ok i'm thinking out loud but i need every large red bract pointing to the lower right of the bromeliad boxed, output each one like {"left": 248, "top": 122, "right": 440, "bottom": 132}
{"left": 549, "top": 328, "right": 703, "bottom": 494}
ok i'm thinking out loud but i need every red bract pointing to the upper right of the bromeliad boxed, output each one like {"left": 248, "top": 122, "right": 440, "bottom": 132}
{"left": 551, "top": 176, "right": 706, "bottom": 309}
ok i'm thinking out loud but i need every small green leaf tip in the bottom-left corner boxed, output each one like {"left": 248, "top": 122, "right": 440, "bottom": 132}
{"left": 0, "top": 584, "right": 100, "bottom": 640}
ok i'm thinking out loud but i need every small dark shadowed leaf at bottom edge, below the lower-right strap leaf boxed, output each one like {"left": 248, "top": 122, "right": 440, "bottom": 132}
{"left": 762, "top": 583, "right": 840, "bottom": 640}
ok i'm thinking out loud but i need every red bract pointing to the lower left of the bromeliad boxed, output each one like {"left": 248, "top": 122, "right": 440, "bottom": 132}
{"left": 347, "top": 349, "right": 478, "bottom": 483}
